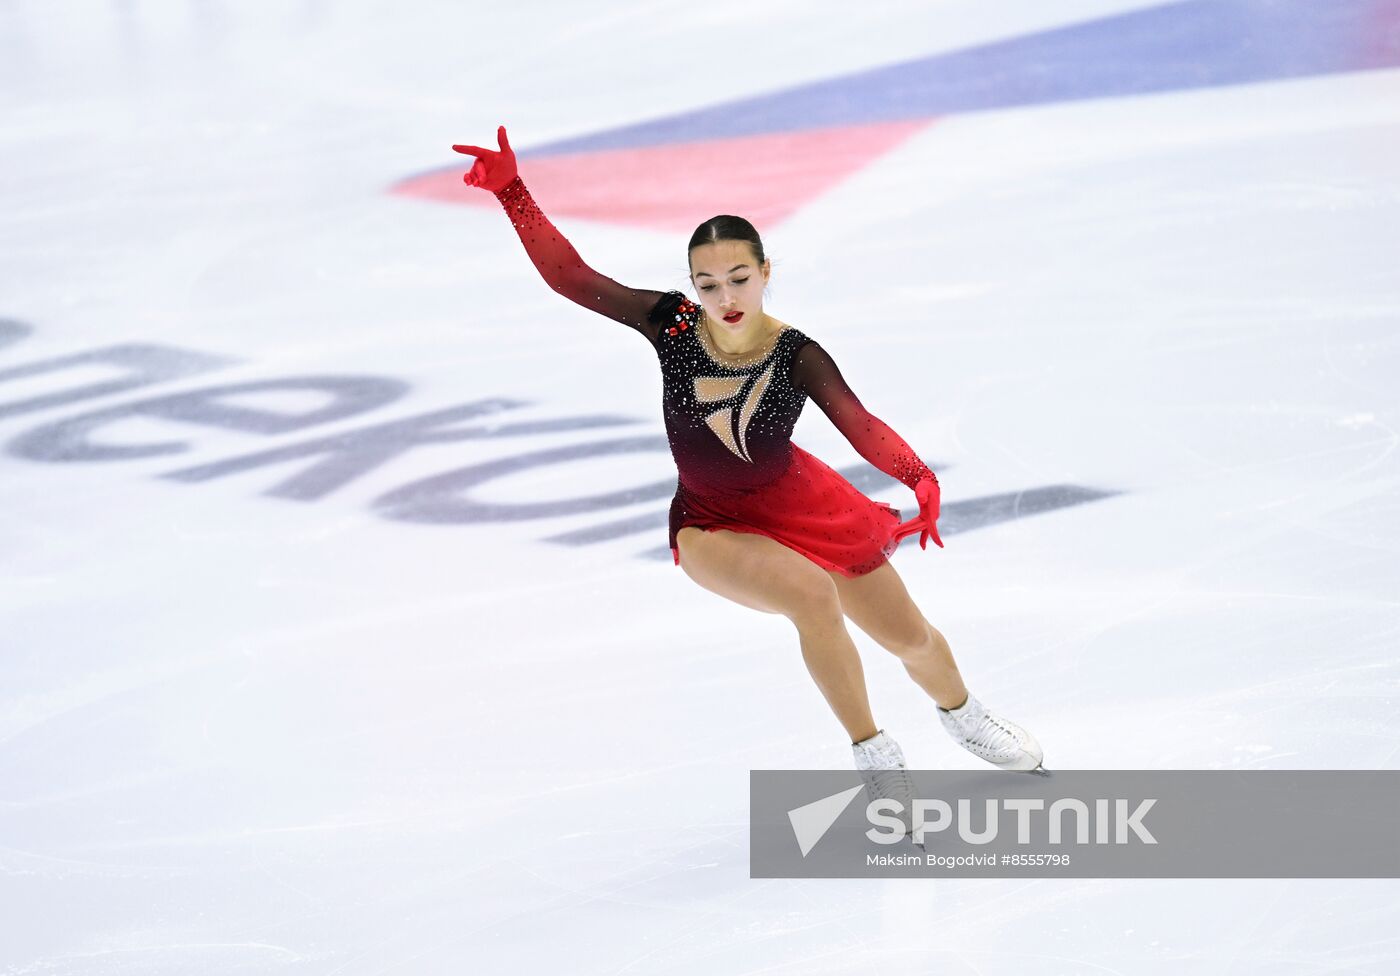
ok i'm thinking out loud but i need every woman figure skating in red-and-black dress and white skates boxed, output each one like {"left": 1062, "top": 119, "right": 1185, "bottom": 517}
{"left": 452, "top": 126, "right": 1042, "bottom": 798}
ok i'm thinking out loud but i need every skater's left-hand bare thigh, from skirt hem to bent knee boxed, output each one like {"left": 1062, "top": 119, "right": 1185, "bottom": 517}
{"left": 676, "top": 525, "right": 840, "bottom": 619}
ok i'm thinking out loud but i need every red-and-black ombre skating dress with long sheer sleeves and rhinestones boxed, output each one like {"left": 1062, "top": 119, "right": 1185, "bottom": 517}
{"left": 497, "top": 176, "right": 934, "bottom": 577}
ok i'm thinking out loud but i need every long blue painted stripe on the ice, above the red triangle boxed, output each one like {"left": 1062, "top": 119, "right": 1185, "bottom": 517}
{"left": 519, "top": 0, "right": 1400, "bottom": 158}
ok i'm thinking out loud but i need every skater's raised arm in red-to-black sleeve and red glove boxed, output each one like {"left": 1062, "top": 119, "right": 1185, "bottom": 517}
{"left": 452, "top": 126, "right": 662, "bottom": 344}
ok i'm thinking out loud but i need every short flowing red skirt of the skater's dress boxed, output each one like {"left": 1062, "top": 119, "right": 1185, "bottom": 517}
{"left": 671, "top": 444, "right": 902, "bottom": 577}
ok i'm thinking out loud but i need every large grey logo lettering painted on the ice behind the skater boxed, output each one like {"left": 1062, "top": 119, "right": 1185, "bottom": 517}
{"left": 0, "top": 319, "right": 1116, "bottom": 562}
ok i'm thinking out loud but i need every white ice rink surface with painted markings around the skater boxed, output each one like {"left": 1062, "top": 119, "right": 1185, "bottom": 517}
{"left": 0, "top": 0, "right": 1400, "bottom": 976}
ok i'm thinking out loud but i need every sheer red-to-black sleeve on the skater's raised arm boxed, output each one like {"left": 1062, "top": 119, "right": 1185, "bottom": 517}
{"left": 496, "top": 176, "right": 662, "bottom": 346}
